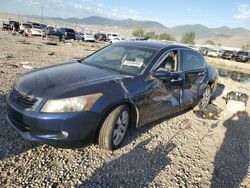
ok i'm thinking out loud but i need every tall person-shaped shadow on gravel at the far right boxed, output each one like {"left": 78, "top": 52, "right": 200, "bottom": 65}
{"left": 211, "top": 112, "right": 250, "bottom": 188}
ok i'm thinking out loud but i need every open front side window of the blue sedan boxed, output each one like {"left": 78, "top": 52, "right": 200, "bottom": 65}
{"left": 157, "top": 50, "right": 179, "bottom": 72}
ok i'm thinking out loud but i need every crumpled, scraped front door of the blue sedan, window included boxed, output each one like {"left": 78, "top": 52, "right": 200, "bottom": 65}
{"left": 140, "top": 50, "right": 182, "bottom": 124}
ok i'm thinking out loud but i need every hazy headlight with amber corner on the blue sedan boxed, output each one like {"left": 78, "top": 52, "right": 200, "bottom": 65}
{"left": 41, "top": 93, "right": 102, "bottom": 113}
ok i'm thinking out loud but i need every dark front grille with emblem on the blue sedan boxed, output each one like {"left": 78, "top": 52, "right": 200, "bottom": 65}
{"left": 11, "top": 89, "right": 37, "bottom": 108}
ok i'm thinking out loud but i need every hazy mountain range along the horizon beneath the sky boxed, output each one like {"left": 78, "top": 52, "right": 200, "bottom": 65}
{"left": 50, "top": 16, "right": 250, "bottom": 47}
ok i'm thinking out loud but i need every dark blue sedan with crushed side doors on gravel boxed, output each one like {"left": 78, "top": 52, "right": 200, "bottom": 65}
{"left": 7, "top": 42, "right": 218, "bottom": 150}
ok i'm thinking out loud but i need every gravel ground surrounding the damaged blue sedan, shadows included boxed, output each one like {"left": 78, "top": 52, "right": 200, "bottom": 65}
{"left": 0, "top": 31, "right": 250, "bottom": 187}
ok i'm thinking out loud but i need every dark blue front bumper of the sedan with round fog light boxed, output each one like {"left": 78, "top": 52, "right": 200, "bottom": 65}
{"left": 6, "top": 96, "right": 101, "bottom": 148}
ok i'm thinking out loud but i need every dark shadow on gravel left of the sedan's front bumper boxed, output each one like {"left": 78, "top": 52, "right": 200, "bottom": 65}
{"left": 0, "top": 91, "right": 37, "bottom": 160}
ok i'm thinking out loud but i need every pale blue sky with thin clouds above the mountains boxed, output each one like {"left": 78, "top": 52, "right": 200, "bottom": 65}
{"left": 0, "top": 0, "right": 250, "bottom": 29}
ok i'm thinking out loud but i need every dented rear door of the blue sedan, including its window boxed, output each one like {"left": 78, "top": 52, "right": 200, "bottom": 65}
{"left": 181, "top": 49, "right": 207, "bottom": 109}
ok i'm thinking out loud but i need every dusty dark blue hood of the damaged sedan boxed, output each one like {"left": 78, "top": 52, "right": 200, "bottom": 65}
{"left": 15, "top": 61, "right": 120, "bottom": 98}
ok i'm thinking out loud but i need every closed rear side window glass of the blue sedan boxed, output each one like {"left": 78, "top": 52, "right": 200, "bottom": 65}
{"left": 181, "top": 50, "right": 204, "bottom": 70}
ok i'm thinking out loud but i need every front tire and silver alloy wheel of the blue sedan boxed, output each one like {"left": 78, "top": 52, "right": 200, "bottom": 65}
{"left": 98, "top": 105, "right": 130, "bottom": 150}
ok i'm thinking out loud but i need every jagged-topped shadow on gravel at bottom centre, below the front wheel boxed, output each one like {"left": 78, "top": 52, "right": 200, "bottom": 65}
{"left": 79, "top": 138, "right": 176, "bottom": 187}
